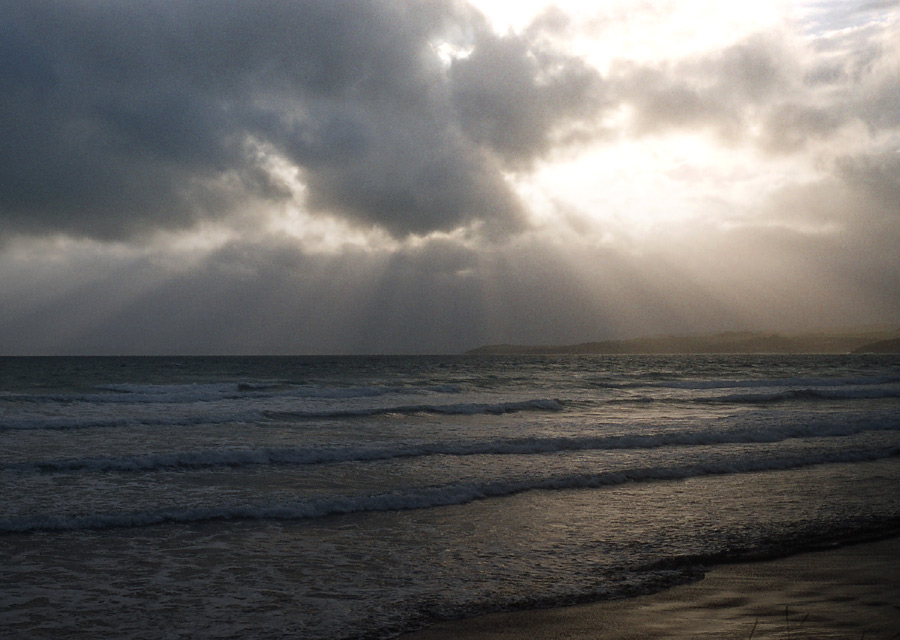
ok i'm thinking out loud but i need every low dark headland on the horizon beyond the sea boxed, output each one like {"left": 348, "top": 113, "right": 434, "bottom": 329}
{"left": 466, "top": 328, "right": 900, "bottom": 355}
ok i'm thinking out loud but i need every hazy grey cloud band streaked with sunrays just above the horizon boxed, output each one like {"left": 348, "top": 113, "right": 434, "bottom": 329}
{"left": 0, "top": 220, "right": 900, "bottom": 355}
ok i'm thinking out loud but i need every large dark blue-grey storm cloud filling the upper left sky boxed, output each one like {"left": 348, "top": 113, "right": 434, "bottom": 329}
{"left": 0, "top": 0, "right": 598, "bottom": 238}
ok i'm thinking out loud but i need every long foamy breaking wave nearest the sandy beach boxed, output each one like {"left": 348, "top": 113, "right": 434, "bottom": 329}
{"left": 0, "top": 447, "right": 900, "bottom": 533}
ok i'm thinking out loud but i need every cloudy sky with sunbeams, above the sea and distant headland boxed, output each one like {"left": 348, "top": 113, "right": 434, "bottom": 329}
{"left": 0, "top": 0, "right": 900, "bottom": 355}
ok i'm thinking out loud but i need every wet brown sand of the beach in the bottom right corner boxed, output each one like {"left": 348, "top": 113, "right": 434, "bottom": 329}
{"left": 399, "top": 538, "right": 900, "bottom": 640}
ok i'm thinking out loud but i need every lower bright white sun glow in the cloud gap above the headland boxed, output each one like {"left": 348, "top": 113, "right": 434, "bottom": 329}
{"left": 518, "top": 134, "right": 822, "bottom": 242}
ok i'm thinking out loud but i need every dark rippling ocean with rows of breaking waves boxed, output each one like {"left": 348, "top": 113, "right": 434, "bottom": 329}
{"left": 0, "top": 355, "right": 900, "bottom": 640}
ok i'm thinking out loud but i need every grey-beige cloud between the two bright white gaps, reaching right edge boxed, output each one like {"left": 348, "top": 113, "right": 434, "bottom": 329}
{"left": 607, "top": 9, "right": 900, "bottom": 154}
